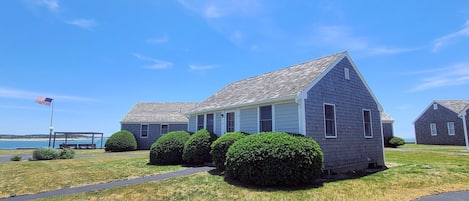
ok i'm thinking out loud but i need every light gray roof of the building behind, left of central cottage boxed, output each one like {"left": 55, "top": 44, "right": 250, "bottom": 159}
{"left": 121, "top": 102, "right": 197, "bottom": 123}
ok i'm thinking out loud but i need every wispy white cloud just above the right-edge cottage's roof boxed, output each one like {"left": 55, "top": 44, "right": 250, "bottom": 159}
{"left": 410, "top": 63, "right": 469, "bottom": 92}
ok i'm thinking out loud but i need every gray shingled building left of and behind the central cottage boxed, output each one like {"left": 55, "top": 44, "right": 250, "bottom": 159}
{"left": 121, "top": 103, "right": 197, "bottom": 149}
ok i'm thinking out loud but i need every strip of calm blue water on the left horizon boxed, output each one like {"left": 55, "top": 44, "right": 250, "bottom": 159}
{"left": 0, "top": 137, "right": 107, "bottom": 149}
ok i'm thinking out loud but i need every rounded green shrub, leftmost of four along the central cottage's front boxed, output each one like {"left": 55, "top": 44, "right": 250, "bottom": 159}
{"left": 150, "top": 131, "right": 191, "bottom": 165}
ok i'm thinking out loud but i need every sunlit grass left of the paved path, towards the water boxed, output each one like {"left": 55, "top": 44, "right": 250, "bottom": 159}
{"left": 0, "top": 150, "right": 181, "bottom": 198}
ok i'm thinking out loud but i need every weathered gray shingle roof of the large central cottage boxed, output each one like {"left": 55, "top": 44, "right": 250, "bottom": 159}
{"left": 191, "top": 52, "right": 347, "bottom": 113}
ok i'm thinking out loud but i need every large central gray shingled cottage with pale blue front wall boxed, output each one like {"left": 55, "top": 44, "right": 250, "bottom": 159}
{"left": 188, "top": 52, "right": 384, "bottom": 172}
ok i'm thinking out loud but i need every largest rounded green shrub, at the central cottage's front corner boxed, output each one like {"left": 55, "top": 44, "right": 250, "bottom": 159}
{"left": 225, "top": 132, "right": 323, "bottom": 186}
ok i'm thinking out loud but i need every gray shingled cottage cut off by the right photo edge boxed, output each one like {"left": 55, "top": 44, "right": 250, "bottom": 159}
{"left": 414, "top": 100, "right": 469, "bottom": 146}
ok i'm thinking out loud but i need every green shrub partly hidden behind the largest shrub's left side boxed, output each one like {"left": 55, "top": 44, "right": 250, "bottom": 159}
{"left": 210, "top": 132, "right": 246, "bottom": 171}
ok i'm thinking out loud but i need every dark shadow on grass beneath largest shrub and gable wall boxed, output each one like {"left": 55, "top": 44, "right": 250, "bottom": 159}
{"left": 208, "top": 167, "right": 387, "bottom": 192}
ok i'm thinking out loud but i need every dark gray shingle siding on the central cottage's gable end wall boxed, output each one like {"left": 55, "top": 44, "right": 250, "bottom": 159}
{"left": 305, "top": 56, "right": 384, "bottom": 170}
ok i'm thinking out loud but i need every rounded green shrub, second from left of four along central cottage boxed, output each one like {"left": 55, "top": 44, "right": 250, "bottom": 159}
{"left": 182, "top": 129, "right": 217, "bottom": 165}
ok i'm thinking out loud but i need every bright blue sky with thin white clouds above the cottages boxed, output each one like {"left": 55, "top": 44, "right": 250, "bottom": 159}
{"left": 0, "top": 0, "right": 469, "bottom": 138}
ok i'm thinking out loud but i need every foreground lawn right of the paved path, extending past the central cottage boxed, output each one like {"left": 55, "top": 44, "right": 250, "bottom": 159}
{"left": 39, "top": 147, "right": 469, "bottom": 201}
